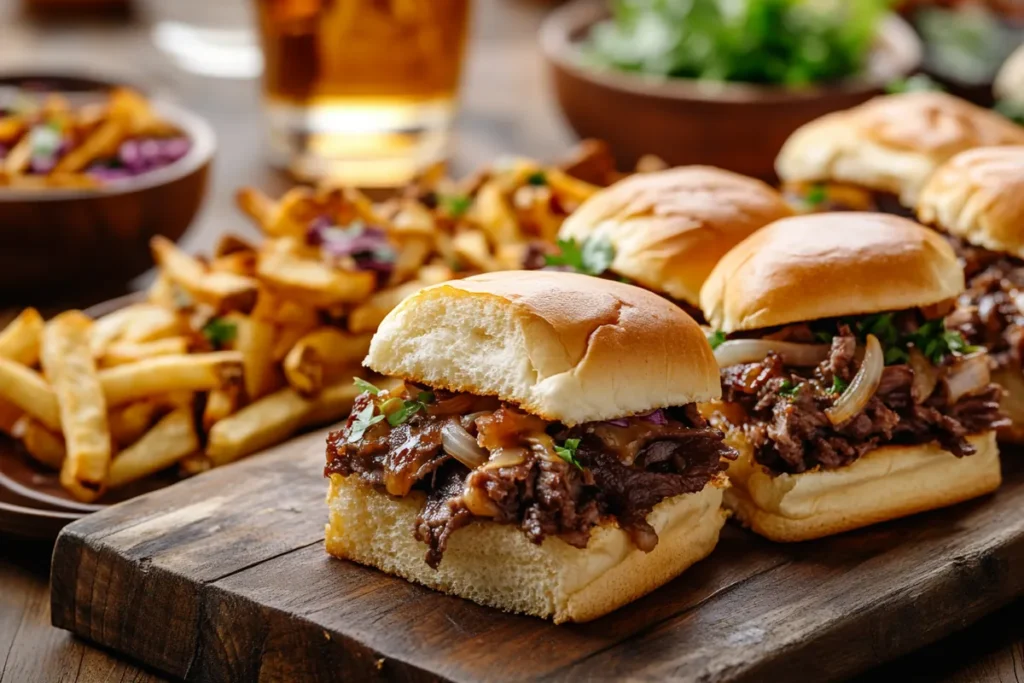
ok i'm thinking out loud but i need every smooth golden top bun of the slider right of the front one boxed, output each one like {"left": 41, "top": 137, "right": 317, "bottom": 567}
{"left": 700, "top": 213, "right": 964, "bottom": 333}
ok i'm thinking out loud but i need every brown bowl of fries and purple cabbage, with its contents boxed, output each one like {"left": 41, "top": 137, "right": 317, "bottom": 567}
{"left": 0, "top": 74, "right": 216, "bottom": 295}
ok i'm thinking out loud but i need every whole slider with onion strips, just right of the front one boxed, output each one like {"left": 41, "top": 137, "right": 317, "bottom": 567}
{"left": 700, "top": 213, "right": 1006, "bottom": 541}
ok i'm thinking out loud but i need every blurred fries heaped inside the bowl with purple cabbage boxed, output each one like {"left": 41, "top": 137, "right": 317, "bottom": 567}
{"left": 0, "top": 88, "right": 181, "bottom": 189}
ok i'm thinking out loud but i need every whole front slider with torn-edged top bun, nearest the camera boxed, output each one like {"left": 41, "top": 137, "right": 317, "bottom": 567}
{"left": 325, "top": 271, "right": 735, "bottom": 623}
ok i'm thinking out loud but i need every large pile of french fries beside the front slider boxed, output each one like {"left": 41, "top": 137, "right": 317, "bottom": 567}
{"left": 0, "top": 143, "right": 630, "bottom": 501}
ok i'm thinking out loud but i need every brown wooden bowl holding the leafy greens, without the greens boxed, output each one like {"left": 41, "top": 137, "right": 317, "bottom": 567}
{"left": 541, "top": 0, "right": 922, "bottom": 180}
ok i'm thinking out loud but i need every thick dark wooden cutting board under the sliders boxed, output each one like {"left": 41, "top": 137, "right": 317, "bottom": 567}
{"left": 52, "top": 432, "right": 1024, "bottom": 681}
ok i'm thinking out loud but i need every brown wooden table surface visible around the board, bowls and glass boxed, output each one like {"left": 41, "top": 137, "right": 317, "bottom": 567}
{"left": 0, "top": 0, "right": 1024, "bottom": 683}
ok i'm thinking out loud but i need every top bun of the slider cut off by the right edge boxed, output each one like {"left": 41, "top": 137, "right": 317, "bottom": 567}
{"left": 918, "top": 146, "right": 1024, "bottom": 258}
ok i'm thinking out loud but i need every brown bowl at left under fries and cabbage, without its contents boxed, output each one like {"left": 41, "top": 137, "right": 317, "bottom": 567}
{"left": 0, "top": 74, "right": 216, "bottom": 301}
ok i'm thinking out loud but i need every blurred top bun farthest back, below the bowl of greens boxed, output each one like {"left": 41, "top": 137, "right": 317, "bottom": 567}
{"left": 775, "top": 92, "right": 1024, "bottom": 207}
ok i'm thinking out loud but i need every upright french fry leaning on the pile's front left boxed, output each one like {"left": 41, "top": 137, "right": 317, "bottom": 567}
{"left": 40, "top": 310, "right": 112, "bottom": 501}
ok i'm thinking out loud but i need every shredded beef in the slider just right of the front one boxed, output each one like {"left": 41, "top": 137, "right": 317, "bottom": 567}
{"left": 722, "top": 313, "right": 1006, "bottom": 473}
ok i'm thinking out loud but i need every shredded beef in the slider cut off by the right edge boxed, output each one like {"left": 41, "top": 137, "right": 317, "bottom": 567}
{"left": 946, "top": 237, "right": 1024, "bottom": 369}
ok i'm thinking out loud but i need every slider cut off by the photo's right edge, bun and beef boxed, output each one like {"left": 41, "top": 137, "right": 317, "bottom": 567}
{"left": 918, "top": 146, "right": 1024, "bottom": 442}
